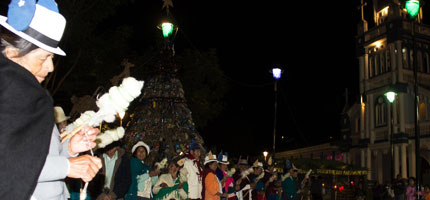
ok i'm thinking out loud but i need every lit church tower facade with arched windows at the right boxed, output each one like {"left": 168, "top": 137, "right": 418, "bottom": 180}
{"left": 277, "top": 0, "right": 430, "bottom": 184}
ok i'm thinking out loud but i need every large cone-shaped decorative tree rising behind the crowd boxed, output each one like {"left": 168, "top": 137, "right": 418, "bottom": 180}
{"left": 123, "top": 17, "right": 203, "bottom": 164}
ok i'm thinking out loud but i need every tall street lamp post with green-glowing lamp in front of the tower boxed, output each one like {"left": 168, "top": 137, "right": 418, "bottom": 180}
{"left": 405, "top": 0, "right": 421, "bottom": 195}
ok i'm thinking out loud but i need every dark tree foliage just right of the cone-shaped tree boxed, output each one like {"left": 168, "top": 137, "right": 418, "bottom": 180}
{"left": 176, "top": 49, "right": 228, "bottom": 128}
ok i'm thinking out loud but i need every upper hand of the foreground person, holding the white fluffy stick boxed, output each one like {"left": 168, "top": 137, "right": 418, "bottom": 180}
{"left": 68, "top": 127, "right": 100, "bottom": 155}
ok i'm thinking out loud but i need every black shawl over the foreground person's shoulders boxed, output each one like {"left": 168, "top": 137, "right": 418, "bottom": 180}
{"left": 0, "top": 53, "right": 54, "bottom": 200}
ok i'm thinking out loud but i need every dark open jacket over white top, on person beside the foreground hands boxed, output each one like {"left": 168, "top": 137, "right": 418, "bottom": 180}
{"left": 89, "top": 148, "right": 131, "bottom": 199}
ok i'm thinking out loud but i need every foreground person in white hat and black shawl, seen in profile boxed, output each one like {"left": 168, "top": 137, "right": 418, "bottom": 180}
{"left": 0, "top": 0, "right": 102, "bottom": 200}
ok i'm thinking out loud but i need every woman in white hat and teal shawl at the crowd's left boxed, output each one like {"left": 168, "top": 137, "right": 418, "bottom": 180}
{"left": 125, "top": 141, "right": 160, "bottom": 200}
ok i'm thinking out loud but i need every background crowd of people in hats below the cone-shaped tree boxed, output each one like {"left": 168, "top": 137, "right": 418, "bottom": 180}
{"left": 54, "top": 103, "right": 322, "bottom": 200}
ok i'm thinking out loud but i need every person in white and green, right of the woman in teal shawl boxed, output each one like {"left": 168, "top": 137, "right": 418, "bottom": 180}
{"left": 152, "top": 160, "right": 188, "bottom": 200}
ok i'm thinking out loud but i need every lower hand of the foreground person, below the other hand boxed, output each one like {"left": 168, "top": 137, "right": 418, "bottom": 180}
{"left": 67, "top": 155, "right": 102, "bottom": 182}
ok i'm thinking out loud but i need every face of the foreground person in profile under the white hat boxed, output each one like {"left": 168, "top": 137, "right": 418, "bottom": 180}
{"left": 6, "top": 47, "right": 54, "bottom": 83}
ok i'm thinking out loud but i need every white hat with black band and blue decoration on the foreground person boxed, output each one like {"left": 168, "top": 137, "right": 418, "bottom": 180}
{"left": 0, "top": 0, "right": 66, "bottom": 56}
